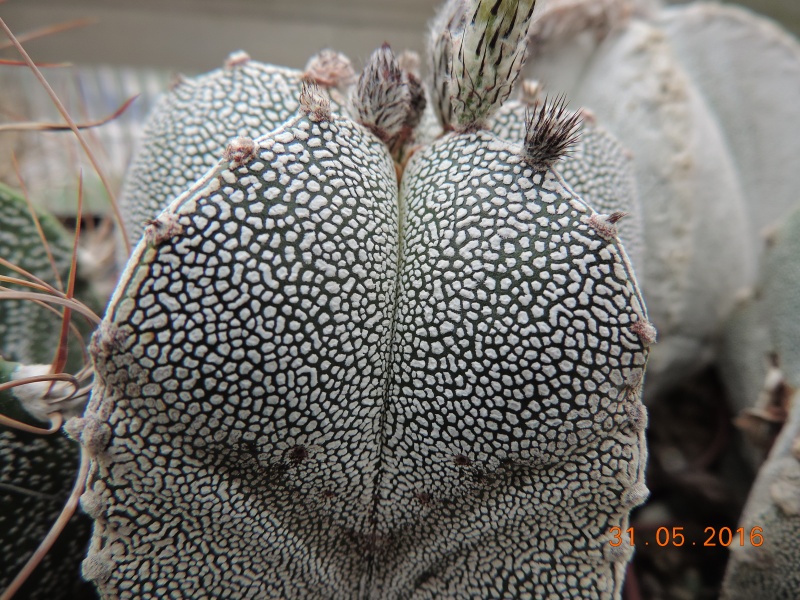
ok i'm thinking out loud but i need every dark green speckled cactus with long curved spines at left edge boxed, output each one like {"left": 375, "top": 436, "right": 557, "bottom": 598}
{"left": 0, "top": 184, "right": 96, "bottom": 599}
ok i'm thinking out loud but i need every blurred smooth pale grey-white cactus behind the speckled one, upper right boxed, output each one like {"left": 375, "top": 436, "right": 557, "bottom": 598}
{"left": 529, "top": 0, "right": 800, "bottom": 394}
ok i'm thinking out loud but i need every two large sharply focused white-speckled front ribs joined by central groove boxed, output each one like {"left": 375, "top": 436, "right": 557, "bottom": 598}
{"left": 76, "top": 2, "right": 654, "bottom": 599}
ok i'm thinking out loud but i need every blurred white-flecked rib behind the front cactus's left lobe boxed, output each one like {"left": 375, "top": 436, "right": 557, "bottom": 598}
{"left": 120, "top": 53, "right": 346, "bottom": 244}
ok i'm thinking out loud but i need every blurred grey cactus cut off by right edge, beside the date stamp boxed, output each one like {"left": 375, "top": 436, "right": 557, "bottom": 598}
{"left": 723, "top": 209, "right": 800, "bottom": 600}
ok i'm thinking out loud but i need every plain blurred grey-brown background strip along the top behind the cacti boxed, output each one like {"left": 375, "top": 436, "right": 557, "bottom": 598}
{"left": 0, "top": 0, "right": 800, "bottom": 72}
